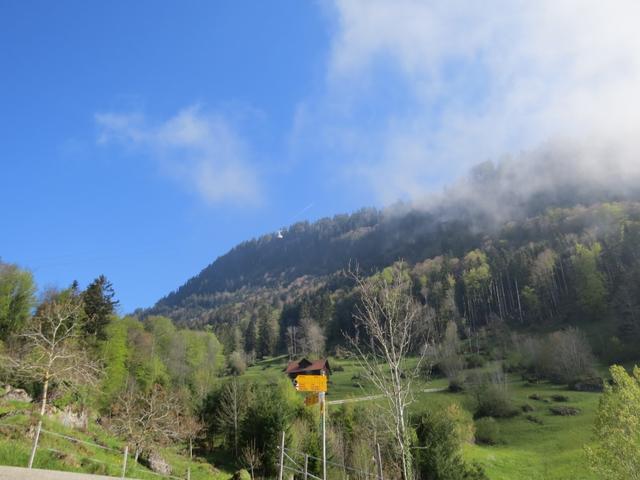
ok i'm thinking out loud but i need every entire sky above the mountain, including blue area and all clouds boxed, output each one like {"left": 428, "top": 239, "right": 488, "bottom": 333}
{"left": 0, "top": 0, "right": 640, "bottom": 313}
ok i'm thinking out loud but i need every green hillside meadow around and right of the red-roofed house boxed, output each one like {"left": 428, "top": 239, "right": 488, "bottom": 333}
{"left": 243, "top": 357, "right": 599, "bottom": 480}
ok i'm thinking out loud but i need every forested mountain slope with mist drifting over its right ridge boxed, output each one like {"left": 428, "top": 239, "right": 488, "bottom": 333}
{"left": 147, "top": 159, "right": 640, "bottom": 362}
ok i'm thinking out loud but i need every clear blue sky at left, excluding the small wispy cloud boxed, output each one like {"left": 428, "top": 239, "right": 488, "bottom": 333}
{"left": 0, "top": 0, "right": 344, "bottom": 311}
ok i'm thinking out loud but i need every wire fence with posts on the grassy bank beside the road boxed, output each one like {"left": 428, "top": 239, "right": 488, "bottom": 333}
{"left": 0, "top": 423, "right": 191, "bottom": 480}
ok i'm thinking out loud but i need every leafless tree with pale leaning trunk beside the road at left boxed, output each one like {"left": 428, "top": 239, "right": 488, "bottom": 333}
{"left": 2, "top": 290, "right": 100, "bottom": 468}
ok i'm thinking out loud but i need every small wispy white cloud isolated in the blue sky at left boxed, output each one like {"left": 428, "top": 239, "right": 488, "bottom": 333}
{"left": 95, "top": 107, "right": 261, "bottom": 205}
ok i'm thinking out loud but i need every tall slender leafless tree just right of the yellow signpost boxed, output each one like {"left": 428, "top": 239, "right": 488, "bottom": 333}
{"left": 349, "top": 262, "right": 432, "bottom": 480}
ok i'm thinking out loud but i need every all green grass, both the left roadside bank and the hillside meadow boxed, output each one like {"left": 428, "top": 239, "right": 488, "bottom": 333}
{"left": 0, "top": 357, "right": 599, "bottom": 480}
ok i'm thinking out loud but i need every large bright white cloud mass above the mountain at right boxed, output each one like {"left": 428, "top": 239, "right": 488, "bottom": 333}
{"left": 310, "top": 0, "right": 640, "bottom": 201}
